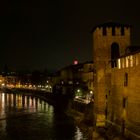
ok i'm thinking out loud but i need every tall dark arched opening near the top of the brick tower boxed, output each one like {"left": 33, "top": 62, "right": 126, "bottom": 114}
{"left": 111, "top": 43, "right": 120, "bottom": 68}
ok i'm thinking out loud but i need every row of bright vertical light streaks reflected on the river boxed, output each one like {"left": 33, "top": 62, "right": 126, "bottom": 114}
{"left": 0, "top": 93, "right": 53, "bottom": 115}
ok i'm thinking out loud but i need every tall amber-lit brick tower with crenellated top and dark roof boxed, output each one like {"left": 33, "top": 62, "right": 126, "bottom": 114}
{"left": 93, "top": 22, "right": 131, "bottom": 126}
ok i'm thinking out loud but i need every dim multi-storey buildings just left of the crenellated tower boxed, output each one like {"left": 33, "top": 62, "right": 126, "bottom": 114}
{"left": 53, "top": 61, "right": 94, "bottom": 98}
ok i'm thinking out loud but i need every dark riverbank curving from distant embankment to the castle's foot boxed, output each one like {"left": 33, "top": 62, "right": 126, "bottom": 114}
{"left": 1, "top": 89, "right": 124, "bottom": 140}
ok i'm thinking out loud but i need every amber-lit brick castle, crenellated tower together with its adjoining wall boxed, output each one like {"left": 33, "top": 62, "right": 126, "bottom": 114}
{"left": 93, "top": 22, "right": 140, "bottom": 137}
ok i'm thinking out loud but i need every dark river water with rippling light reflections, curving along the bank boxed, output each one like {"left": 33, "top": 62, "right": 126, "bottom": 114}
{"left": 0, "top": 92, "right": 87, "bottom": 140}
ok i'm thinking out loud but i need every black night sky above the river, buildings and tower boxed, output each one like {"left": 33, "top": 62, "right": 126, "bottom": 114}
{"left": 0, "top": 0, "right": 140, "bottom": 70}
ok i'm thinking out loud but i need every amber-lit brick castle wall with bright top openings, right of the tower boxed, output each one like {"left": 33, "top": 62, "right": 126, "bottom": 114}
{"left": 107, "top": 53, "right": 140, "bottom": 135}
